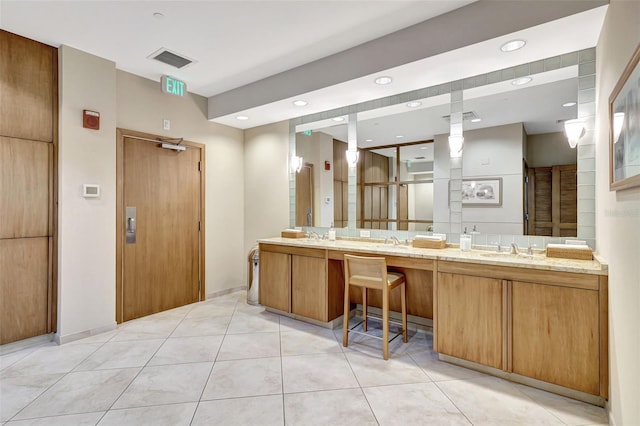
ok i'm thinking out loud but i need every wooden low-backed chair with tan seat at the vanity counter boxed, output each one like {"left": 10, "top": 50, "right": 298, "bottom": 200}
{"left": 342, "top": 254, "right": 407, "bottom": 360}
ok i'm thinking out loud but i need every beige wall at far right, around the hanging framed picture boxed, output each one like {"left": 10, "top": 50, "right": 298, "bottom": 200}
{"left": 595, "top": 0, "right": 640, "bottom": 425}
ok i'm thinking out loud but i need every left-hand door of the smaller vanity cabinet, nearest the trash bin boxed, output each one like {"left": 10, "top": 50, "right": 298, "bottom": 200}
{"left": 258, "top": 251, "right": 291, "bottom": 312}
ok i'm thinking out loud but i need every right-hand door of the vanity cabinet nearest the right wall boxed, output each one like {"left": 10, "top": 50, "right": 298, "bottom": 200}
{"left": 512, "top": 282, "right": 600, "bottom": 395}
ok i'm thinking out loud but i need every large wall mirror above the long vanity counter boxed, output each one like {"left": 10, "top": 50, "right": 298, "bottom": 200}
{"left": 292, "top": 48, "right": 596, "bottom": 245}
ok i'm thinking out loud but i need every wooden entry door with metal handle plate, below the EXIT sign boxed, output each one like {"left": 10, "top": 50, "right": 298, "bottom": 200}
{"left": 119, "top": 132, "right": 202, "bottom": 321}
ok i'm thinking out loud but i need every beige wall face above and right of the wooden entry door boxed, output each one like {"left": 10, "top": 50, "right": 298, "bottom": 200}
{"left": 117, "top": 71, "right": 246, "bottom": 294}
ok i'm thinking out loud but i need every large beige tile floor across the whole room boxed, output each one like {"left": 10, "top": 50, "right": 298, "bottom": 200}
{"left": 0, "top": 292, "right": 607, "bottom": 426}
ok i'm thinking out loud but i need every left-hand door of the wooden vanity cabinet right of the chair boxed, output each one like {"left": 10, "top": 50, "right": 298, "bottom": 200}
{"left": 436, "top": 272, "right": 506, "bottom": 369}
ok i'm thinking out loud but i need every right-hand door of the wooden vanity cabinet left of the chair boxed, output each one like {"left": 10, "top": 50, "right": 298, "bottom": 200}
{"left": 291, "top": 255, "right": 328, "bottom": 322}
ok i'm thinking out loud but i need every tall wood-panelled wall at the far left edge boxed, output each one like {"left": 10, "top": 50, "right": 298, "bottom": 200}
{"left": 0, "top": 30, "right": 58, "bottom": 344}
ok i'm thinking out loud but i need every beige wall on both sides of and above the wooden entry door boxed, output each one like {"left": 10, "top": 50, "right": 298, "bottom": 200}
{"left": 57, "top": 46, "right": 245, "bottom": 343}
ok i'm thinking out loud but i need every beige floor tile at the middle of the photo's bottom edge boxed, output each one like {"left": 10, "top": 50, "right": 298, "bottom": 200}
{"left": 284, "top": 389, "right": 377, "bottom": 426}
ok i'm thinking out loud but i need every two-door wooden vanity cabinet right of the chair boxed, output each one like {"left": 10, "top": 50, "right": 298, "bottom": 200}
{"left": 434, "top": 261, "right": 608, "bottom": 398}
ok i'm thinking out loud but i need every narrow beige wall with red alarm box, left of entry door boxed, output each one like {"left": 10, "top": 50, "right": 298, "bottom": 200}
{"left": 56, "top": 46, "right": 116, "bottom": 343}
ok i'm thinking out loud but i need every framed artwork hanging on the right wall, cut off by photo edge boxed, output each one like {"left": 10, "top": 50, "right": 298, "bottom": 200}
{"left": 609, "top": 45, "right": 640, "bottom": 191}
